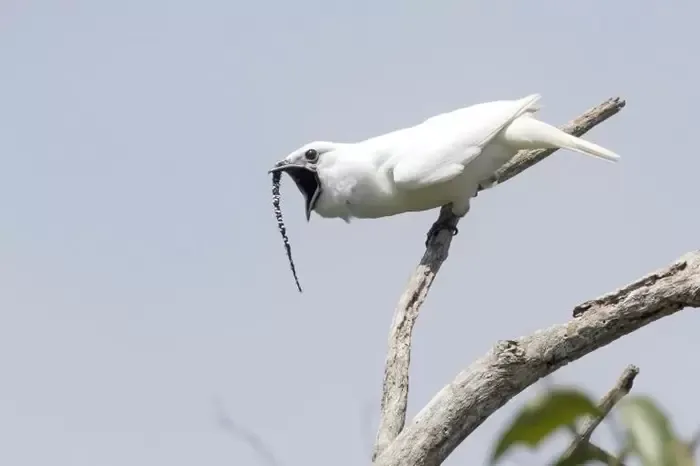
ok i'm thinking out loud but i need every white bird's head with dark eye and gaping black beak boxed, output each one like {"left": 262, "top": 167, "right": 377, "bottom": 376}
{"left": 269, "top": 141, "right": 338, "bottom": 221}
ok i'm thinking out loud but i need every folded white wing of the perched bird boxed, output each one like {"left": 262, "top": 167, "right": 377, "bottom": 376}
{"left": 389, "top": 94, "right": 540, "bottom": 190}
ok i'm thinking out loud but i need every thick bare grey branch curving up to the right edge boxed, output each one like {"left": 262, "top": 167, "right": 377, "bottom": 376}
{"left": 375, "top": 251, "right": 700, "bottom": 466}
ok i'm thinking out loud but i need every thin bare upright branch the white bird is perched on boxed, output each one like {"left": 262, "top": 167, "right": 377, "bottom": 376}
{"left": 372, "top": 98, "right": 625, "bottom": 460}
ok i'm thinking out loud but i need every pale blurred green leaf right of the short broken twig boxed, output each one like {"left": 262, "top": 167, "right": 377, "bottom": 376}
{"left": 619, "top": 395, "right": 684, "bottom": 466}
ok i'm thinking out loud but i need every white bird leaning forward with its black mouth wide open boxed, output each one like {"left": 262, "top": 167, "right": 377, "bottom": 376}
{"left": 270, "top": 94, "right": 620, "bottom": 246}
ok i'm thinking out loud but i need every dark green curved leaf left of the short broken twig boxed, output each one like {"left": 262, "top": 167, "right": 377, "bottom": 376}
{"left": 491, "top": 389, "right": 600, "bottom": 464}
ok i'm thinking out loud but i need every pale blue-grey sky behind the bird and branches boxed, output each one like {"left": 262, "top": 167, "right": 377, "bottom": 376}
{"left": 0, "top": 0, "right": 700, "bottom": 466}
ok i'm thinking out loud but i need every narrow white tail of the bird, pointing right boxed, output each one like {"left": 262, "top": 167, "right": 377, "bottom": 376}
{"left": 503, "top": 113, "right": 620, "bottom": 162}
